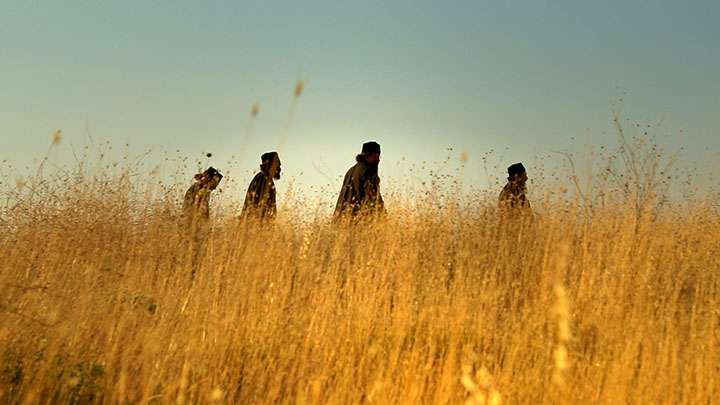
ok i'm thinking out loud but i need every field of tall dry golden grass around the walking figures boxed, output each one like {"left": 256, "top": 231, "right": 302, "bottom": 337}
{"left": 0, "top": 142, "right": 720, "bottom": 404}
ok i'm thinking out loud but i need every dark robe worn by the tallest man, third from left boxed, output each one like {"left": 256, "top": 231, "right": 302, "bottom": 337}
{"left": 335, "top": 160, "right": 385, "bottom": 217}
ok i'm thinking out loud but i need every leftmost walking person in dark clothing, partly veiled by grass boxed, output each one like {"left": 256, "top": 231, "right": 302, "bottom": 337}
{"left": 183, "top": 167, "right": 223, "bottom": 277}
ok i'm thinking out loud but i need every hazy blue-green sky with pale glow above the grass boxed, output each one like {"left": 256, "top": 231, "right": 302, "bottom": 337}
{"left": 0, "top": 0, "right": 720, "bottom": 199}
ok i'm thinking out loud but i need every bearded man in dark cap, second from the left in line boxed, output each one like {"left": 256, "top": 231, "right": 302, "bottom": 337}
{"left": 240, "top": 152, "right": 282, "bottom": 220}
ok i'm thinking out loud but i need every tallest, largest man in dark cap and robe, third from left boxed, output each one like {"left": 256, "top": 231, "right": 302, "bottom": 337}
{"left": 335, "top": 141, "right": 385, "bottom": 218}
